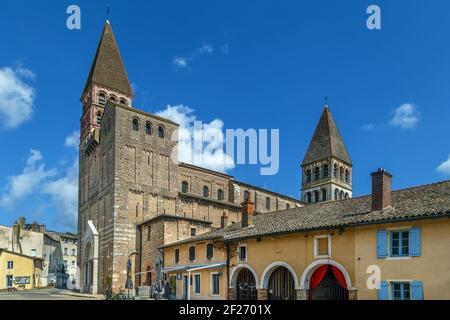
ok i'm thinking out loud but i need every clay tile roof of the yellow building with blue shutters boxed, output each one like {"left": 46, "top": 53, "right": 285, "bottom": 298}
{"left": 224, "top": 181, "right": 450, "bottom": 240}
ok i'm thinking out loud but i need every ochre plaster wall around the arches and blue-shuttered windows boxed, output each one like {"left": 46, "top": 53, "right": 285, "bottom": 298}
{"left": 164, "top": 218, "right": 450, "bottom": 300}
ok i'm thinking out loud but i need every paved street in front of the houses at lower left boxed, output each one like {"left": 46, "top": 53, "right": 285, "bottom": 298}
{"left": 0, "top": 288, "right": 101, "bottom": 300}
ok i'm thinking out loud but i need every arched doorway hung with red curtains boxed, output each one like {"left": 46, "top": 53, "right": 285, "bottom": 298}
{"left": 308, "top": 264, "right": 348, "bottom": 300}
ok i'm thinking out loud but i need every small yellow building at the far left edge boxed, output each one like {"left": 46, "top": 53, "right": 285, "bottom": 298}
{"left": 0, "top": 250, "right": 43, "bottom": 289}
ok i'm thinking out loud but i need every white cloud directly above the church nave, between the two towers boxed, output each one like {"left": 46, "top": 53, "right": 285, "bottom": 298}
{"left": 157, "top": 105, "right": 234, "bottom": 172}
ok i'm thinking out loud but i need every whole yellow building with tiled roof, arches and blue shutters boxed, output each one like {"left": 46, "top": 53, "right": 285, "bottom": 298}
{"left": 162, "top": 171, "right": 450, "bottom": 300}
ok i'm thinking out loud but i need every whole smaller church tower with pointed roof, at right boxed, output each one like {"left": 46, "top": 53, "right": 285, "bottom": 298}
{"left": 302, "top": 105, "right": 352, "bottom": 203}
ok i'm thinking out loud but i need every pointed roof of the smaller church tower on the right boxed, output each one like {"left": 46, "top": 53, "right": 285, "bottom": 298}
{"left": 302, "top": 102, "right": 352, "bottom": 165}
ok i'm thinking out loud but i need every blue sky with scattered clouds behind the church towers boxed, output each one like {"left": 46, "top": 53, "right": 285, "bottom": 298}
{"left": 0, "top": 0, "right": 450, "bottom": 230}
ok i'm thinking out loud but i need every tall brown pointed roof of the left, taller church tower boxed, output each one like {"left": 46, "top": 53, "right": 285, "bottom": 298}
{"left": 83, "top": 20, "right": 134, "bottom": 97}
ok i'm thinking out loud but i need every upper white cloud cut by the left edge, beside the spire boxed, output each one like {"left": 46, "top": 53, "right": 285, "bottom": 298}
{"left": 0, "top": 67, "right": 35, "bottom": 129}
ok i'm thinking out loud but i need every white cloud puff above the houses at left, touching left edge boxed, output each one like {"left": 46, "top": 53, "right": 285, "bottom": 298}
{"left": 0, "top": 149, "right": 56, "bottom": 209}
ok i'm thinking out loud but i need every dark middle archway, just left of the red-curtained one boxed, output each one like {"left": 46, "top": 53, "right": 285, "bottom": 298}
{"left": 269, "top": 267, "right": 296, "bottom": 300}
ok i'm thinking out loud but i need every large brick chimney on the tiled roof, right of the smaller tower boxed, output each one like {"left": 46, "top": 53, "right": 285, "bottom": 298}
{"left": 372, "top": 168, "right": 392, "bottom": 211}
